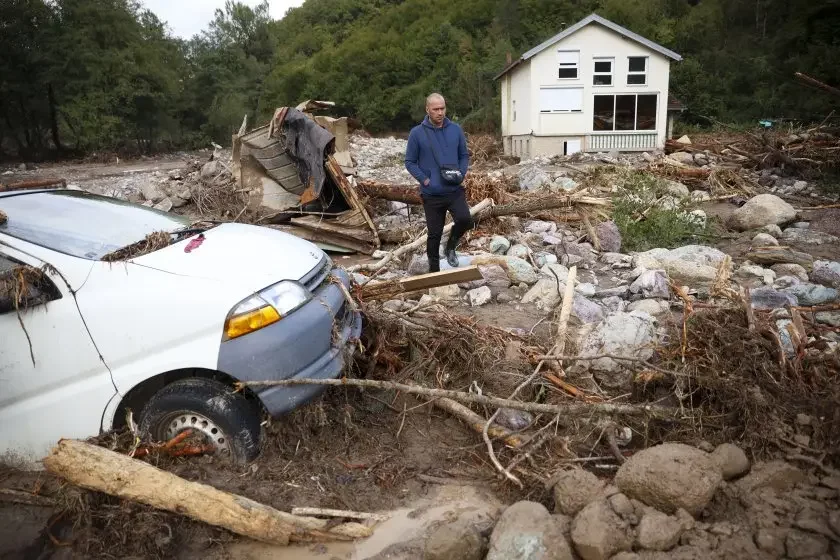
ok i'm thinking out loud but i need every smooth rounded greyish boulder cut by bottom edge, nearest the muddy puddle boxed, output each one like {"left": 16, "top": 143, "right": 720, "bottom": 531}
{"left": 486, "top": 501, "right": 573, "bottom": 560}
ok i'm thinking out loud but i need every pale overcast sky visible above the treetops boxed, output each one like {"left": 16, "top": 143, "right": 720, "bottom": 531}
{"left": 141, "top": 0, "right": 303, "bottom": 39}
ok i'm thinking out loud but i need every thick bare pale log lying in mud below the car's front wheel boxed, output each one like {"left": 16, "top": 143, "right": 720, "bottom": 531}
{"left": 43, "top": 439, "right": 372, "bottom": 545}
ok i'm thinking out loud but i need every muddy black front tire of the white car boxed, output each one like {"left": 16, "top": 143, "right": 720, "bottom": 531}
{"left": 138, "top": 377, "right": 261, "bottom": 464}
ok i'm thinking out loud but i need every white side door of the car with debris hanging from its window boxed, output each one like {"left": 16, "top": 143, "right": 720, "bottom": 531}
{"left": 0, "top": 244, "right": 116, "bottom": 464}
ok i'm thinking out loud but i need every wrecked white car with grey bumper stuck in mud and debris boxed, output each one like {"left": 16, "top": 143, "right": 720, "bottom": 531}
{"left": 0, "top": 189, "right": 361, "bottom": 463}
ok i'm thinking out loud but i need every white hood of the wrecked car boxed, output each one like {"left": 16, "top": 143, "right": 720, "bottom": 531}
{"left": 132, "top": 224, "right": 325, "bottom": 292}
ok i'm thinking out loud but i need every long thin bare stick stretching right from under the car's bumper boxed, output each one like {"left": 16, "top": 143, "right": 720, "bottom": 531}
{"left": 235, "top": 378, "right": 677, "bottom": 420}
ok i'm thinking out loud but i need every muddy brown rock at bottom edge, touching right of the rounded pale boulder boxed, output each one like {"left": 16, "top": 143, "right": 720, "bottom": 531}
{"left": 572, "top": 499, "right": 633, "bottom": 560}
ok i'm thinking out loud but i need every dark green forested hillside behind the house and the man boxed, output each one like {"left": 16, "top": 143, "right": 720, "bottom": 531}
{"left": 0, "top": 0, "right": 840, "bottom": 157}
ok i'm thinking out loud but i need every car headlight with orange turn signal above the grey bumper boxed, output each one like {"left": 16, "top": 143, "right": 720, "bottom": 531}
{"left": 223, "top": 280, "right": 312, "bottom": 340}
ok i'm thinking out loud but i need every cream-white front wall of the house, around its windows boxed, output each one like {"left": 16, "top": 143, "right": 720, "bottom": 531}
{"left": 528, "top": 23, "right": 670, "bottom": 146}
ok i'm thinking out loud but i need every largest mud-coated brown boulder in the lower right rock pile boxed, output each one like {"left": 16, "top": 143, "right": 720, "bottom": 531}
{"left": 615, "top": 443, "right": 722, "bottom": 515}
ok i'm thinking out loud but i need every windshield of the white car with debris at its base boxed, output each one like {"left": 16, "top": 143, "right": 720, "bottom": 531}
{"left": 0, "top": 190, "right": 190, "bottom": 260}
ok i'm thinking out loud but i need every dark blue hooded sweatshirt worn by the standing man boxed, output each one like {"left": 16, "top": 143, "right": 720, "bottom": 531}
{"left": 405, "top": 116, "right": 470, "bottom": 196}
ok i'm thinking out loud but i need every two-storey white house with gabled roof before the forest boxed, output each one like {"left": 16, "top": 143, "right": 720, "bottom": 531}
{"left": 495, "top": 14, "right": 682, "bottom": 158}
